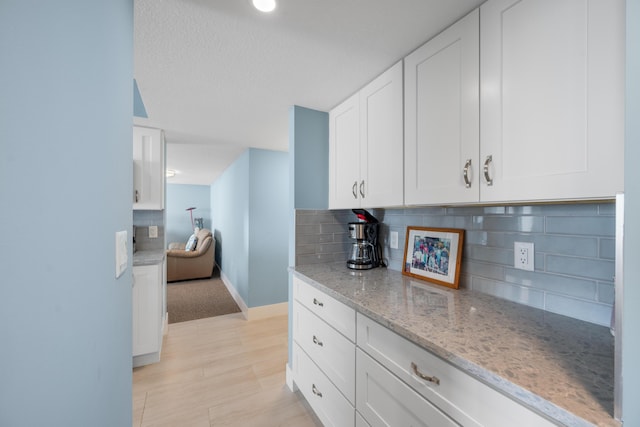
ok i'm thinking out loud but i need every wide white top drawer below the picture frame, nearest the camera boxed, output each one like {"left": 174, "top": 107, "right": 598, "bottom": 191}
{"left": 357, "top": 314, "right": 554, "bottom": 427}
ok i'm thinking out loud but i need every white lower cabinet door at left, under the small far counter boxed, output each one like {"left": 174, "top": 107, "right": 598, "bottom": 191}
{"left": 132, "top": 264, "right": 162, "bottom": 356}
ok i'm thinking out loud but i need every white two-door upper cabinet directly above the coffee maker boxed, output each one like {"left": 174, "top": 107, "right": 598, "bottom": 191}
{"left": 329, "top": 62, "right": 403, "bottom": 209}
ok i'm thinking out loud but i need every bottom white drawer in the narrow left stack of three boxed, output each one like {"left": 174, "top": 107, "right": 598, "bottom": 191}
{"left": 293, "top": 344, "right": 355, "bottom": 427}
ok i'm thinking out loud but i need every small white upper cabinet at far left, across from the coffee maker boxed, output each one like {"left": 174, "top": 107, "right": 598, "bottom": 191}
{"left": 133, "top": 126, "right": 165, "bottom": 210}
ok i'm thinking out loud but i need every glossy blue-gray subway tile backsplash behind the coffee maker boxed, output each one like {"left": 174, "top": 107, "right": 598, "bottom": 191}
{"left": 296, "top": 202, "right": 615, "bottom": 326}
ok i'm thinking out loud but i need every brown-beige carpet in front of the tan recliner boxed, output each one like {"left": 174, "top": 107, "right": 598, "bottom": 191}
{"left": 167, "top": 273, "right": 240, "bottom": 323}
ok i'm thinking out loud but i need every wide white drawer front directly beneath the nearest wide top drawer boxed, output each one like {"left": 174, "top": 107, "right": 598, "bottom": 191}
{"left": 356, "top": 350, "right": 459, "bottom": 427}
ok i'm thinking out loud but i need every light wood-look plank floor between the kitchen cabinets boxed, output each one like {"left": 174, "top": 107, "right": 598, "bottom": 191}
{"left": 133, "top": 313, "right": 321, "bottom": 427}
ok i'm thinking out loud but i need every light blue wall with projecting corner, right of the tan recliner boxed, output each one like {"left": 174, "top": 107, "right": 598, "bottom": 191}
{"left": 211, "top": 148, "right": 289, "bottom": 308}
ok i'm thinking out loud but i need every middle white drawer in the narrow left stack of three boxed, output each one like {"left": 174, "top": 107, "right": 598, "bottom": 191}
{"left": 293, "top": 302, "right": 356, "bottom": 404}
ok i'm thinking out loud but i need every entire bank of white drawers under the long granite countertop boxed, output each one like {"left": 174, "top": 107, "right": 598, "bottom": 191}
{"left": 292, "top": 277, "right": 554, "bottom": 427}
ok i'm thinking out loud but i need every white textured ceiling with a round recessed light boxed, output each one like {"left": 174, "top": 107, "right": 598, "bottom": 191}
{"left": 134, "top": 0, "right": 484, "bottom": 185}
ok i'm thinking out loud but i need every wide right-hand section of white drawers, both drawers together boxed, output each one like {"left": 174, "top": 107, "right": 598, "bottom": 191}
{"left": 356, "top": 313, "right": 554, "bottom": 427}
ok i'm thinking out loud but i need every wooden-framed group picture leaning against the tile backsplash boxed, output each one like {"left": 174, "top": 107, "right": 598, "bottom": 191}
{"left": 402, "top": 226, "right": 464, "bottom": 289}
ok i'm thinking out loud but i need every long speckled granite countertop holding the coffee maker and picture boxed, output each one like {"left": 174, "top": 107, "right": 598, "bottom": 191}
{"left": 293, "top": 263, "right": 621, "bottom": 426}
